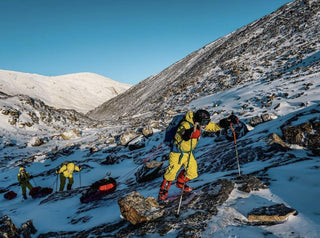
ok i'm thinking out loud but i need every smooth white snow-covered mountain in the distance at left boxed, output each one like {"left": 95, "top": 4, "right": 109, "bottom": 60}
{"left": 0, "top": 70, "right": 130, "bottom": 113}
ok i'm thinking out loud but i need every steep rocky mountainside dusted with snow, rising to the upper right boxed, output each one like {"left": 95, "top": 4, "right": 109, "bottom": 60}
{"left": 88, "top": 0, "right": 320, "bottom": 120}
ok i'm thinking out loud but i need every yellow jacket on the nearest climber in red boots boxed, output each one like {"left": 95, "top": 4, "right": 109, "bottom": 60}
{"left": 173, "top": 111, "right": 221, "bottom": 152}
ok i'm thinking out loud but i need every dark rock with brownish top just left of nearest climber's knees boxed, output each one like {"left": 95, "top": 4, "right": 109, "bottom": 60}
{"left": 135, "top": 161, "right": 163, "bottom": 183}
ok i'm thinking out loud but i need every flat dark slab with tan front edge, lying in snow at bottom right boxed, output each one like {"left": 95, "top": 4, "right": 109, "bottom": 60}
{"left": 248, "top": 204, "right": 297, "bottom": 225}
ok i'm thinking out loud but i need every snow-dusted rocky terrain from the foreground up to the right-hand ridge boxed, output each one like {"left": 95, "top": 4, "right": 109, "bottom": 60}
{"left": 0, "top": 0, "right": 320, "bottom": 238}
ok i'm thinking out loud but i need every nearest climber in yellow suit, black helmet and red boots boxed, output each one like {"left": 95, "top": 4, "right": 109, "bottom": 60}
{"left": 159, "top": 109, "right": 238, "bottom": 200}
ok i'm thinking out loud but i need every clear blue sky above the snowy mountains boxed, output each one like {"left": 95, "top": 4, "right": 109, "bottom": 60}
{"left": 0, "top": 0, "right": 291, "bottom": 84}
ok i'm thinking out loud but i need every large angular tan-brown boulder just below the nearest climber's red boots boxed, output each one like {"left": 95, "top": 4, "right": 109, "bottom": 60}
{"left": 118, "top": 191, "right": 164, "bottom": 225}
